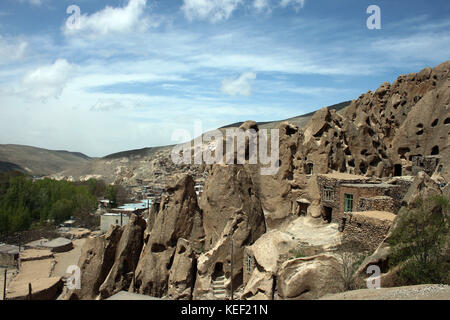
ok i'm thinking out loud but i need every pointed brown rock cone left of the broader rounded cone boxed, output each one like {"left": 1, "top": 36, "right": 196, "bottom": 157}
{"left": 135, "top": 175, "right": 204, "bottom": 297}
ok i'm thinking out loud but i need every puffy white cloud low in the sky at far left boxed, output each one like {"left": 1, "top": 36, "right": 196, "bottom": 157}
{"left": 18, "top": 59, "right": 73, "bottom": 101}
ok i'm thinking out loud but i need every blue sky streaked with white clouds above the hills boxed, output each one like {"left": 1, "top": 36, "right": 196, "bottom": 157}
{"left": 0, "top": 0, "right": 450, "bottom": 156}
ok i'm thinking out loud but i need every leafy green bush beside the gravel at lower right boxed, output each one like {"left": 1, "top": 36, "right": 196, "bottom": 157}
{"left": 388, "top": 196, "right": 450, "bottom": 284}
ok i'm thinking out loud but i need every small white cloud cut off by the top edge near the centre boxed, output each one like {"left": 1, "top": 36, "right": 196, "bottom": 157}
{"left": 181, "top": 0, "right": 242, "bottom": 23}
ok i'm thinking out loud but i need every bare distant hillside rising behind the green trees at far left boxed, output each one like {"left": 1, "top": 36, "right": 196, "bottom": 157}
{"left": 0, "top": 144, "right": 92, "bottom": 176}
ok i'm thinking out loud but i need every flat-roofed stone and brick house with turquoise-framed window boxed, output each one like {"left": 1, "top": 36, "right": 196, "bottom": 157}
{"left": 317, "top": 173, "right": 414, "bottom": 251}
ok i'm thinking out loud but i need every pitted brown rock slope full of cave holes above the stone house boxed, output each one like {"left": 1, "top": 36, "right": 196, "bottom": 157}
{"left": 255, "top": 62, "right": 450, "bottom": 228}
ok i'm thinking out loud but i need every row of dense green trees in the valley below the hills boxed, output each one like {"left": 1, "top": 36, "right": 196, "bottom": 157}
{"left": 0, "top": 174, "right": 123, "bottom": 234}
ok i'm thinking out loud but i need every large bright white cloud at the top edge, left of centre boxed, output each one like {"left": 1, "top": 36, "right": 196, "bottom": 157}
{"left": 64, "top": 0, "right": 150, "bottom": 37}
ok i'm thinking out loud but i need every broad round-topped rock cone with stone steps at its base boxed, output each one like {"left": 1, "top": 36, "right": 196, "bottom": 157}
{"left": 193, "top": 165, "right": 266, "bottom": 299}
